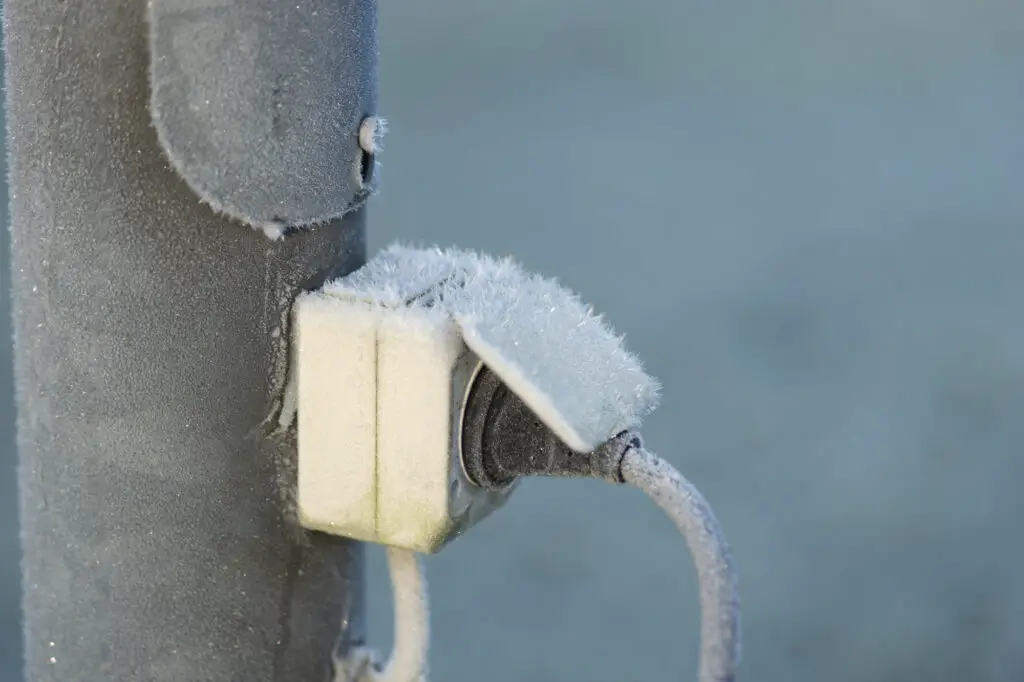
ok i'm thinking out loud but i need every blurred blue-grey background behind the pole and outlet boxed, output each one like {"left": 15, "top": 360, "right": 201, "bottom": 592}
{"left": 0, "top": 0, "right": 1024, "bottom": 682}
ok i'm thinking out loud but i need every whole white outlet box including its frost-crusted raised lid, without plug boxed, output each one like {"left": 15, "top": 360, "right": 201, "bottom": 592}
{"left": 293, "top": 241, "right": 658, "bottom": 552}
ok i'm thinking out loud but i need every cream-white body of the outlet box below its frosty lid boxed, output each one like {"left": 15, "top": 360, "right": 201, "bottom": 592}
{"left": 294, "top": 274, "right": 511, "bottom": 553}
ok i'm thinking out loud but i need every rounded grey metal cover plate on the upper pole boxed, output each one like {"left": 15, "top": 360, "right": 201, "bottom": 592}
{"left": 148, "top": 0, "right": 377, "bottom": 229}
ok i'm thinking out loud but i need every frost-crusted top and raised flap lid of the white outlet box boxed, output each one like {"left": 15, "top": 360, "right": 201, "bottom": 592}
{"left": 325, "top": 245, "right": 659, "bottom": 452}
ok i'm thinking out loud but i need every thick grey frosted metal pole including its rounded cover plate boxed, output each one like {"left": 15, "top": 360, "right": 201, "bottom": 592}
{"left": 4, "top": 0, "right": 377, "bottom": 682}
